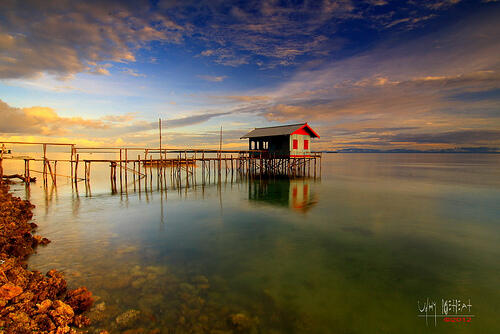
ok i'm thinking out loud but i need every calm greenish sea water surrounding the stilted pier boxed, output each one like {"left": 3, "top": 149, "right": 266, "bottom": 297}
{"left": 6, "top": 154, "right": 500, "bottom": 333}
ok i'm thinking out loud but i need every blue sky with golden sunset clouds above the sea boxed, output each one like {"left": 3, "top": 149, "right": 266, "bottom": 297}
{"left": 0, "top": 0, "right": 500, "bottom": 150}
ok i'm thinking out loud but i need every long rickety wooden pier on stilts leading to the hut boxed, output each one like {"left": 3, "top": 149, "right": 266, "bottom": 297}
{"left": 0, "top": 142, "right": 322, "bottom": 192}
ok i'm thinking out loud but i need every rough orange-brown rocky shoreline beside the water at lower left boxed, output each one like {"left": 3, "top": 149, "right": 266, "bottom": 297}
{"left": 0, "top": 182, "right": 93, "bottom": 334}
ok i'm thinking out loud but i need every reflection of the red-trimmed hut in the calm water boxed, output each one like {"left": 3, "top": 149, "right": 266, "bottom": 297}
{"left": 248, "top": 179, "right": 317, "bottom": 212}
